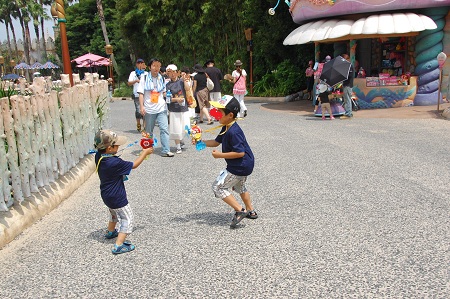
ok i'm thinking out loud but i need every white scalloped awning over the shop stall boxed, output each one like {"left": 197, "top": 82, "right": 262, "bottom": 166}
{"left": 283, "top": 13, "right": 437, "bottom": 45}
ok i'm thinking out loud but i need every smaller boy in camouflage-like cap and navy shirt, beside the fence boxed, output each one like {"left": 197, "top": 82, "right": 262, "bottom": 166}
{"left": 94, "top": 130, "right": 153, "bottom": 254}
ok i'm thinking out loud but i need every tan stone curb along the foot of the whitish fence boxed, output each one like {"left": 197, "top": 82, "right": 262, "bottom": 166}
{"left": 0, "top": 155, "right": 95, "bottom": 249}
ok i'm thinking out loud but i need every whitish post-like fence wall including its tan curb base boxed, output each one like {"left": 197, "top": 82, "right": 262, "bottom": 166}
{"left": 0, "top": 74, "right": 108, "bottom": 248}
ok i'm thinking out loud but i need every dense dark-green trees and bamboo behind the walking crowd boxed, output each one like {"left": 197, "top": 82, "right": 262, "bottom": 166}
{"left": 57, "top": 0, "right": 320, "bottom": 96}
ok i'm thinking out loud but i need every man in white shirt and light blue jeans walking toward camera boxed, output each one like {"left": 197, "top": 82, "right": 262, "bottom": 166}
{"left": 137, "top": 58, "right": 174, "bottom": 157}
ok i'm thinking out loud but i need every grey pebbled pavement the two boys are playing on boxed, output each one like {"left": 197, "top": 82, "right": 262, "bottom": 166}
{"left": 0, "top": 101, "right": 450, "bottom": 298}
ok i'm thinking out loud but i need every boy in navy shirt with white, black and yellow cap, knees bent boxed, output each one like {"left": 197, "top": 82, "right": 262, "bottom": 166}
{"left": 200, "top": 96, "right": 258, "bottom": 228}
